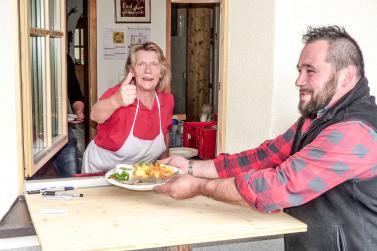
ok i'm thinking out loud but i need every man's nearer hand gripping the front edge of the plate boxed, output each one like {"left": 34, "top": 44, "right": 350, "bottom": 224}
{"left": 153, "top": 174, "right": 205, "bottom": 200}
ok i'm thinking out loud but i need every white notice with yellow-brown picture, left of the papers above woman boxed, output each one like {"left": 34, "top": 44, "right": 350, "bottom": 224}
{"left": 103, "top": 28, "right": 127, "bottom": 60}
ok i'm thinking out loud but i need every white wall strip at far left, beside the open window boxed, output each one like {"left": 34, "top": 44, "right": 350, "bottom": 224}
{"left": 0, "top": 1, "right": 19, "bottom": 219}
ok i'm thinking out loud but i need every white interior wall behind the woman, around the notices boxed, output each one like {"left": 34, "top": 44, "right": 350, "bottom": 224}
{"left": 97, "top": 0, "right": 166, "bottom": 96}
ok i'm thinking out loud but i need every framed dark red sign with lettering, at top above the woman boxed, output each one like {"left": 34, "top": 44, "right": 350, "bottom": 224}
{"left": 115, "top": 0, "right": 151, "bottom": 23}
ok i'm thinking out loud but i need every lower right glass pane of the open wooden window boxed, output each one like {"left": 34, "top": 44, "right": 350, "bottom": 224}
{"left": 50, "top": 38, "right": 63, "bottom": 141}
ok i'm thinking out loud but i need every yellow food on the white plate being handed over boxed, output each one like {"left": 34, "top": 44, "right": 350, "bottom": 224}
{"left": 133, "top": 162, "right": 174, "bottom": 179}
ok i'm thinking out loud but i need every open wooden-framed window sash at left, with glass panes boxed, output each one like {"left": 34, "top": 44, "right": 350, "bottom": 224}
{"left": 20, "top": 0, "right": 67, "bottom": 177}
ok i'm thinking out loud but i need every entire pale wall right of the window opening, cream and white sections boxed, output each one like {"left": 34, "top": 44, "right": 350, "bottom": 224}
{"left": 226, "top": 0, "right": 377, "bottom": 152}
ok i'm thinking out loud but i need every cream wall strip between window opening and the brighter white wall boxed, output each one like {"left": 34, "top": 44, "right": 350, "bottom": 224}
{"left": 224, "top": 0, "right": 275, "bottom": 153}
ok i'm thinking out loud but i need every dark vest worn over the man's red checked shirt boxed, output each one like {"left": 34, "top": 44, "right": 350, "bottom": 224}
{"left": 284, "top": 78, "right": 377, "bottom": 251}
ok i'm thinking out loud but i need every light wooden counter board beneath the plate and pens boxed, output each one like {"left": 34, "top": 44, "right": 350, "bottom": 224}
{"left": 25, "top": 186, "right": 306, "bottom": 251}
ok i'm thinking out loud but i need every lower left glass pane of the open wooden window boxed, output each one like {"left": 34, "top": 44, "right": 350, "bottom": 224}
{"left": 30, "top": 37, "right": 47, "bottom": 157}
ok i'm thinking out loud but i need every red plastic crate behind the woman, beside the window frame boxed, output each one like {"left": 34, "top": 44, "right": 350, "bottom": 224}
{"left": 183, "top": 121, "right": 217, "bottom": 159}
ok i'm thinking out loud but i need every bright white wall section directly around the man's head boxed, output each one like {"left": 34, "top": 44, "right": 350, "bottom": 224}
{"left": 270, "top": 0, "right": 377, "bottom": 137}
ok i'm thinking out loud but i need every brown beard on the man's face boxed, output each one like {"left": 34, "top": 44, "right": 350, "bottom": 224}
{"left": 298, "top": 74, "right": 337, "bottom": 119}
